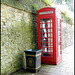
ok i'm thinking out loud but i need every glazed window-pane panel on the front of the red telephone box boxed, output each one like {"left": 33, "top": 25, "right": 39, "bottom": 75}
{"left": 40, "top": 17, "right": 53, "bottom": 57}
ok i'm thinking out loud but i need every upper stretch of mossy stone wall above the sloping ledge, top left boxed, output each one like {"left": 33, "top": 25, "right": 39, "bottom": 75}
{"left": 1, "top": 0, "right": 47, "bottom": 13}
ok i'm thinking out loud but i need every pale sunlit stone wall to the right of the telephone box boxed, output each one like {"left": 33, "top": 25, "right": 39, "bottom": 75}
{"left": 62, "top": 22, "right": 74, "bottom": 49}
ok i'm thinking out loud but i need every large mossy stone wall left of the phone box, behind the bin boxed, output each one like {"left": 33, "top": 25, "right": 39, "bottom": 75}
{"left": 1, "top": 4, "right": 36, "bottom": 75}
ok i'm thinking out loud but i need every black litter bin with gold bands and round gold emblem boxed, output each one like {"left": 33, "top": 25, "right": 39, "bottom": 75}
{"left": 25, "top": 49, "right": 41, "bottom": 72}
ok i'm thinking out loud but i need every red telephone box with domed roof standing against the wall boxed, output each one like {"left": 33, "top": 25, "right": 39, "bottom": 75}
{"left": 37, "top": 7, "right": 62, "bottom": 64}
